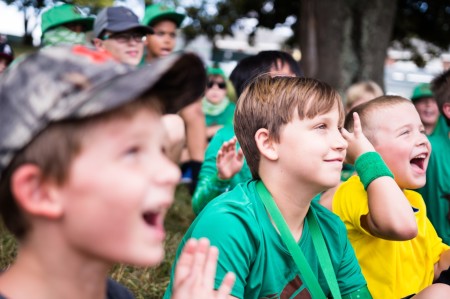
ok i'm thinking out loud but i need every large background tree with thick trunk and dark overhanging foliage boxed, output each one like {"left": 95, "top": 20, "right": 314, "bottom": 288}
{"left": 182, "top": 0, "right": 450, "bottom": 91}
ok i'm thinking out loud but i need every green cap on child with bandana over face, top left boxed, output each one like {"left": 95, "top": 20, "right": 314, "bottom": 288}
{"left": 41, "top": 4, "right": 95, "bottom": 35}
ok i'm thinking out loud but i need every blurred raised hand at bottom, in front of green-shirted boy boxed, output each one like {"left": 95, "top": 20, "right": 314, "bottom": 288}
{"left": 172, "top": 238, "right": 235, "bottom": 299}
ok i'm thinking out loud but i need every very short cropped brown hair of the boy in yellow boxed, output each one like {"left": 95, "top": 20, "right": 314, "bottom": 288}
{"left": 344, "top": 95, "right": 413, "bottom": 144}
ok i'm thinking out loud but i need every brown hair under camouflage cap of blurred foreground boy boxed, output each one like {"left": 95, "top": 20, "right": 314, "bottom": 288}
{"left": 0, "top": 98, "right": 161, "bottom": 239}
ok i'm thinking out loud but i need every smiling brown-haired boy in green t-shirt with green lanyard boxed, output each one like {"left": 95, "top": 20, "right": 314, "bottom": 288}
{"left": 165, "top": 75, "right": 371, "bottom": 299}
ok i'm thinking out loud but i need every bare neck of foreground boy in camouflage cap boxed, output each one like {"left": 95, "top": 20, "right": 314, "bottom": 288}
{"left": 0, "top": 231, "right": 109, "bottom": 299}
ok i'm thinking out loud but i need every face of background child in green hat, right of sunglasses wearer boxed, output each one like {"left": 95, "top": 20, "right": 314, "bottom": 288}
{"left": 146, "top": 20, "right": 177, "bottom": 58}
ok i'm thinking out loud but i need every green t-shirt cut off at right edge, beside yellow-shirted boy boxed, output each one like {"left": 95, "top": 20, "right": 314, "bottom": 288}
{"left": 418, "top": 123, "right": 450, "bottom": 245}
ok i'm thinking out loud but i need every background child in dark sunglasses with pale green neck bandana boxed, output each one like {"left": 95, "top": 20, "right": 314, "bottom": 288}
{"left": 202, "top": 67, "right": 236, "bottom": 140}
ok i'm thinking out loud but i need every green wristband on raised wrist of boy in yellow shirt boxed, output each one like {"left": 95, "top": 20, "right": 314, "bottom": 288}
{"left": 355, "top": 152, "right": 394, "bottom": 190}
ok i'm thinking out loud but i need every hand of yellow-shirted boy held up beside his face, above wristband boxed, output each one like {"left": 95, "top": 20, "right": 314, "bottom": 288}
{"left": 342, "top": 112, "right": 375, "bottom": 164}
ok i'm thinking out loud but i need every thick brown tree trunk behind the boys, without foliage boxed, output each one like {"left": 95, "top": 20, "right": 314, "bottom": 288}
{"left": 299, "top": 0, "right": 397, "bottom": 92}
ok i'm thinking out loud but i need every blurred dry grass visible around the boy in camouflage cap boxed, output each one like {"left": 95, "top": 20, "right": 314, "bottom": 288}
{"left": 0, "top": 185, "right": 194, "bottom": 299}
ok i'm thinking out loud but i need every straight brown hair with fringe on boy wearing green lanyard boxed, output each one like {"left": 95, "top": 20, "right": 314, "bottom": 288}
{"left": 234, "top": 75, "right": 344, "bottom": 179}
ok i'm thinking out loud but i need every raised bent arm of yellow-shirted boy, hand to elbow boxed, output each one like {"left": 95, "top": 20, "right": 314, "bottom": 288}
{"left": 342, "top": 113, "right": 417, "bottom": 241}
